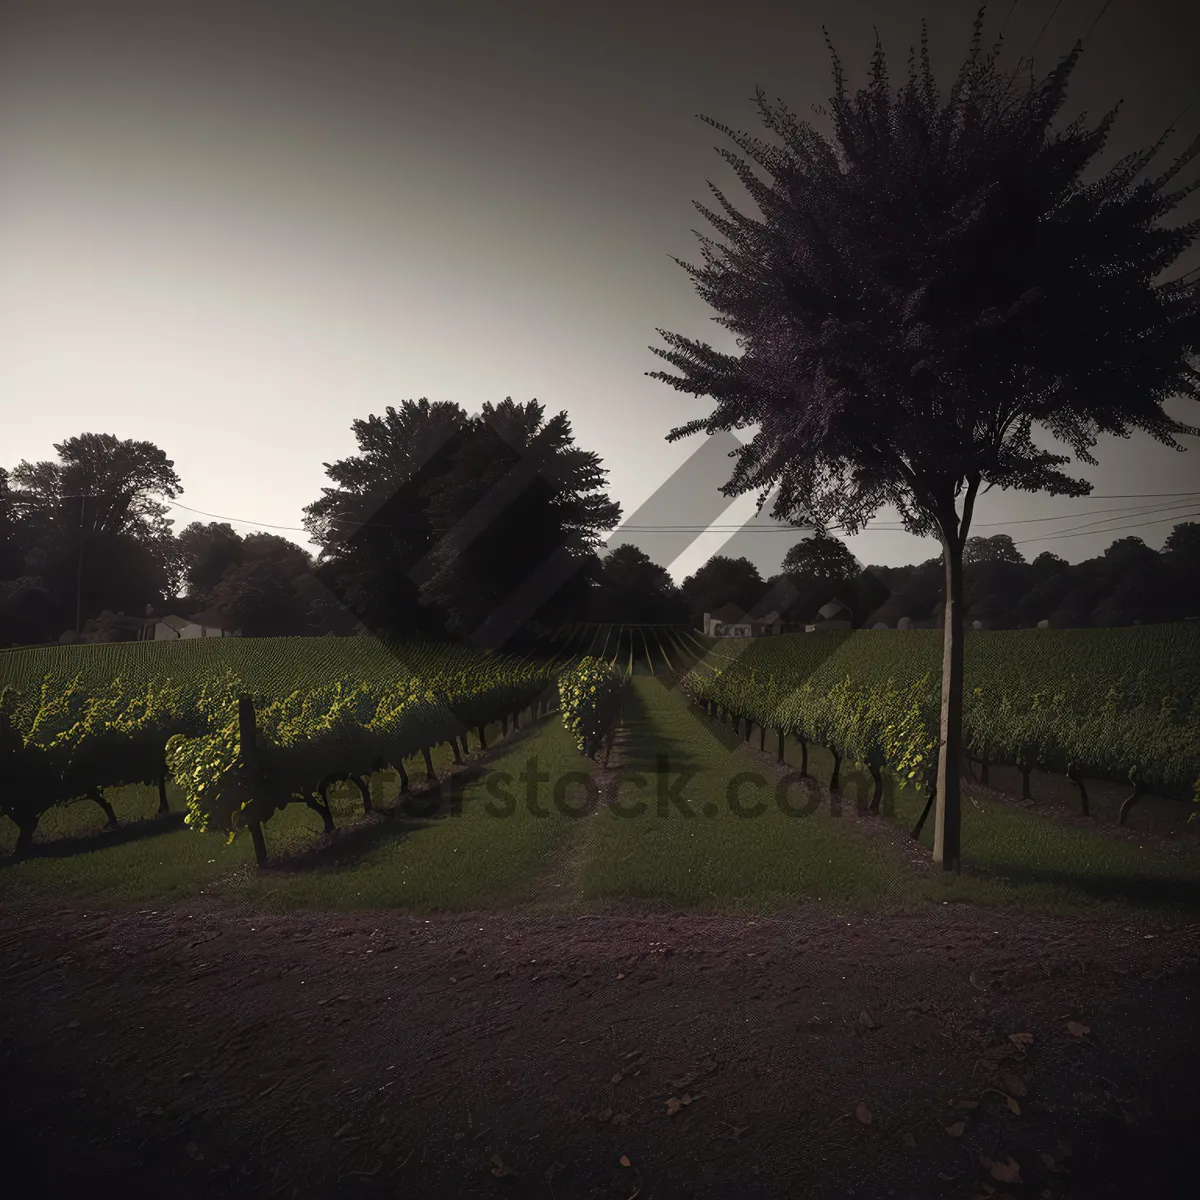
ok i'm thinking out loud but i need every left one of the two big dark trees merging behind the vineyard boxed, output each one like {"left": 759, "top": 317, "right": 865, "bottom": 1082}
{"left": 304, "top": 398, "right": 470, "bottom": 634}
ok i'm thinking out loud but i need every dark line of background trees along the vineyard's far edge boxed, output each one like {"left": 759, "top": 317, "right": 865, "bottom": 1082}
{"left": 0, "top": 424, "right": 1200, "bottom": 646}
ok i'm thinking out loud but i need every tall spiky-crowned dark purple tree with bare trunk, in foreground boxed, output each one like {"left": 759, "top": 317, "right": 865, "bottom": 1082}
{"left": 648, "top": 11, "right": 1200, "bottom": 870}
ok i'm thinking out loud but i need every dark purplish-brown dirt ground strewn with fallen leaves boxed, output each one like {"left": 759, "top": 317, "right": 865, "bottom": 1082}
{"left": 0, "top": 906, "right": 1200, "bottom": 1200}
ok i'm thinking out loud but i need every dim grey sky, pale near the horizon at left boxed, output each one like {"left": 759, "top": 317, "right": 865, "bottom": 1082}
{"left": 0, "top": 0, "right": 1200, "bottom": 578}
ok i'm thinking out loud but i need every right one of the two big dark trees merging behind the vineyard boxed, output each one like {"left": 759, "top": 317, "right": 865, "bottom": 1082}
{"left": 420, "top": 397, "right": 620, "bottom": 646}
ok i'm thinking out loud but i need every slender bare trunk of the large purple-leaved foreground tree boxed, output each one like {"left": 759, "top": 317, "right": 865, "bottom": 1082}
{"left": 934, "top": 513, "right": 979, "bottom": 872}
